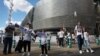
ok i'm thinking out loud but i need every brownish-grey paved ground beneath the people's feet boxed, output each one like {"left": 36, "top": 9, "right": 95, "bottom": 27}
{"left": 0, "top": 44, "right": 100, "bottom": 56}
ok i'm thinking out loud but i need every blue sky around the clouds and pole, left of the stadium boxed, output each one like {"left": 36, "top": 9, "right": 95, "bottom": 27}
{"left": 0, "top": 0, "right": 39, "bottom": 29}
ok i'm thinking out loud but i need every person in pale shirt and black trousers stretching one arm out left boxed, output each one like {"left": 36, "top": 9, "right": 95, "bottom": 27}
{"left": 15, "top": 23, "right": 35, "bottom": 56}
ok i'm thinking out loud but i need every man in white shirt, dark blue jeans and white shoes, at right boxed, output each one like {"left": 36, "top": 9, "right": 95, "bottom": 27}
{"left": 74, "top": 22, "right": 83, "bottom": 54}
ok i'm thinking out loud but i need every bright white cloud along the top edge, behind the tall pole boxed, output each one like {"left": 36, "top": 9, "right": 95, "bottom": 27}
{"left": 4, "top": 0, "right": 33, "bottom": 13}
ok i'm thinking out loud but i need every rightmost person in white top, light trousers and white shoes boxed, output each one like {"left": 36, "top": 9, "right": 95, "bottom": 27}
{"left": 83, "top": 28, "right": 94, "bottom": 53}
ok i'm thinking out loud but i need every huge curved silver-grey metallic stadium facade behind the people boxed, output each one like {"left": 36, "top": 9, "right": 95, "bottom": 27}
{"left": 22, "top": 0, "right": 96, "bottom": 32}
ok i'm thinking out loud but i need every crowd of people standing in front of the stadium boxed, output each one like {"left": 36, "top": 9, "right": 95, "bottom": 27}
{"left": 3, "top": 22, "right": 94, "bottom": 56}
